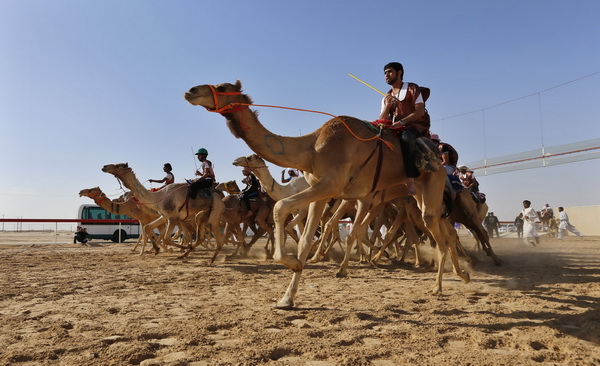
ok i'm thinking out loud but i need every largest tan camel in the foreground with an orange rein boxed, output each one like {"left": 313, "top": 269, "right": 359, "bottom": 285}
{"left": 184, "top": 80, "right": 470, "bottom": 309}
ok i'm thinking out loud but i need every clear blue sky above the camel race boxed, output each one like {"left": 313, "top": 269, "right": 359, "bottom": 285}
{"left": 0, "top": 0, "right": 600, "bottom": 220}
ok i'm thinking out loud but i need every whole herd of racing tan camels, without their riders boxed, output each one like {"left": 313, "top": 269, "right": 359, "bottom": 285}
{"left": 80, "top": 81, "right": 501, "bottom": 309}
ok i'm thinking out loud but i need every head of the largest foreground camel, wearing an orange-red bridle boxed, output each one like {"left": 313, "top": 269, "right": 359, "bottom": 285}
{"left": 184, "top": 80, "right": 246, "bottom": 111}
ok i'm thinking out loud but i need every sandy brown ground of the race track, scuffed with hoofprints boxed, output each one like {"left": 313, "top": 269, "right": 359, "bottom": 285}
{"left": 0, "top": 232, "right": 600, "bottom": 366}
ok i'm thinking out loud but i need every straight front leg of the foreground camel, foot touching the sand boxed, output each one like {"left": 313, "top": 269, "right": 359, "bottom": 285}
{"left": 275, "top": 200, "right": 327, "bottom": 309}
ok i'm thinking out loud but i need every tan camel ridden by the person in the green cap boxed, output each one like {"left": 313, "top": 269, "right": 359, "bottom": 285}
{"left": 102, "top": 163, "right": 224, "bottom": 263}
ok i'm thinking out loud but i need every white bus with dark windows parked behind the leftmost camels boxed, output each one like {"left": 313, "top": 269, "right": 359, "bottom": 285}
{"left": 77, "top": 204, "right": 140, "bottom": 243}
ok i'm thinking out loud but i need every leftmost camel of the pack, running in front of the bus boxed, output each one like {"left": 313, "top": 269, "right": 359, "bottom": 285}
{"left": 79, "top": 187, "right": 165, "bottom": 255}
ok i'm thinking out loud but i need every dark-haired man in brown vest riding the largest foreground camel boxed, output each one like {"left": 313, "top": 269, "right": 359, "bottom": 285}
{"left": 379, "top": 62, "right": 431, "bottom": 194}
